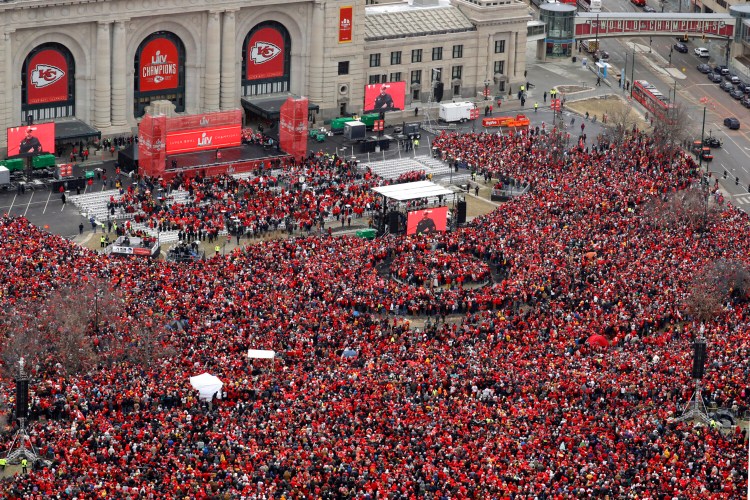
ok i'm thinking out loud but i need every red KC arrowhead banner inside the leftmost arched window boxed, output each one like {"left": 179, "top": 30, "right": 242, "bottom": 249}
{"left": 26, "top": 49, "right": 70, "bottom": 104}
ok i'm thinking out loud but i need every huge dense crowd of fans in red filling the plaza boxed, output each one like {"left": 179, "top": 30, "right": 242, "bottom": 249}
{"left": 0, "top": 128, "right": 750, "bottom": 499}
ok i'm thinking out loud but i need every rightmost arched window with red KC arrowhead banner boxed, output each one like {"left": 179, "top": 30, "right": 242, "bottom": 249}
{"left": 242, "top": 21, "right": 292, "bottom": 96}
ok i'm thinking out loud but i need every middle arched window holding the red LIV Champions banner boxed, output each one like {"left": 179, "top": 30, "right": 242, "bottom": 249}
{"left": 133, "top": 31, "right": 185, "bottom": 118}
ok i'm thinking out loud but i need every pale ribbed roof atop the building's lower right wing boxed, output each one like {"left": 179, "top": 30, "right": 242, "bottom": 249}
{"left": 365, "top": 5, "right": 476, "bottom": 41}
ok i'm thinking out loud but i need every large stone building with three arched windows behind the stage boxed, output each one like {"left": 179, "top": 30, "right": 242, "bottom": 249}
{"left": 0, "top": 0, "right": 530, "bottom": 152}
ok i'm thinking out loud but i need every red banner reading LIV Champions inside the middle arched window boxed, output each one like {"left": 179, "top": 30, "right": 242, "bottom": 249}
{"left": 139, "top": 37, "right": 180, "bottom": 92}
